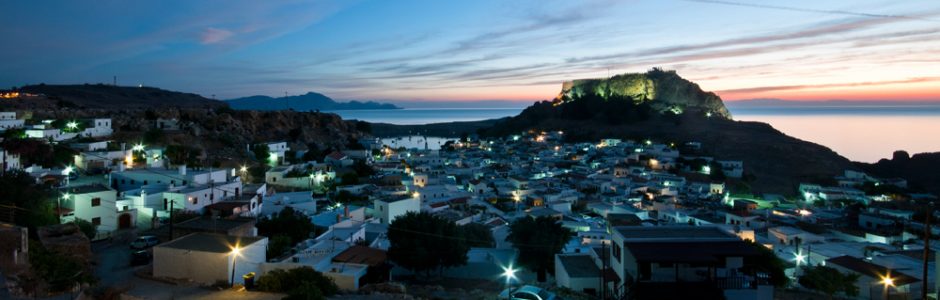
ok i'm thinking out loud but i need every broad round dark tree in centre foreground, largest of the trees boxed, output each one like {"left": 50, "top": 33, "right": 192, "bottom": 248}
{"left": 388, "top": 212, "right": 470, "bottom": 277}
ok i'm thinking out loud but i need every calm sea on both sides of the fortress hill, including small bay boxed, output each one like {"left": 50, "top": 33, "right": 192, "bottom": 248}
{"left": 333, "top": 105, "right": 940, "bottom": 162}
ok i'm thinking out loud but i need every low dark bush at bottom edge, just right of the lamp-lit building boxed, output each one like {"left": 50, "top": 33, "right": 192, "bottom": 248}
{"left": 258, "top": 266, "right": 339, "bottom": 300}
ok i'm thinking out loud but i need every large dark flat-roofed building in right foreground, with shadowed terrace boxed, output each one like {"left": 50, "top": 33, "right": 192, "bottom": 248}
{"left": 610, "top": 226, "right": 774, "bottom": 300}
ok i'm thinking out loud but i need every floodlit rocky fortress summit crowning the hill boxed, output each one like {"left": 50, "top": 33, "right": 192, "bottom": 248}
{"left": 555, "top": 68, "right": 731, "bottom": 119}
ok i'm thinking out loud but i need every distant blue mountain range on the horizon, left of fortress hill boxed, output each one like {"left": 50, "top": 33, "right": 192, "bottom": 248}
{"left": 232, "top": 92, "right": 401, "bottom": 111}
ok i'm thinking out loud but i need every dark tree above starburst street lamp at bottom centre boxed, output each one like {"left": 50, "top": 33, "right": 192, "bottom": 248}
{"left": 506, "top": 217, "right": 574, "bottom": 282}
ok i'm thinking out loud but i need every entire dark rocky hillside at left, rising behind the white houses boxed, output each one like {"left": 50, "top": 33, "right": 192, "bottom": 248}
{"left": 0, "top": 85, "right": 367, "bottom": 166}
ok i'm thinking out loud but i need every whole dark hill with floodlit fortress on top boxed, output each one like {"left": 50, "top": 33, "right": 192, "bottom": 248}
{"left": 479, "top": 69, "right": 857, "bottom": 195}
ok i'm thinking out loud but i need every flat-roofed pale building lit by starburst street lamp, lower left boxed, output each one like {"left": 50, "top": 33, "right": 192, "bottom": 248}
{"left": 153, "top": 233, "right": 268, "bottom": 284}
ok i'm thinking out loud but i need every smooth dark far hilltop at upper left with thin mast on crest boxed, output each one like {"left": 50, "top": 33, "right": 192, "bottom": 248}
{"left": 19, "top": 84, "right": 226, "bottom": 109}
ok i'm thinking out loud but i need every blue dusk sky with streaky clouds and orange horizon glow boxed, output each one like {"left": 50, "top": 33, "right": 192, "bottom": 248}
{"left": 0, "top": 0, "right": 940, "bottom": 102}
